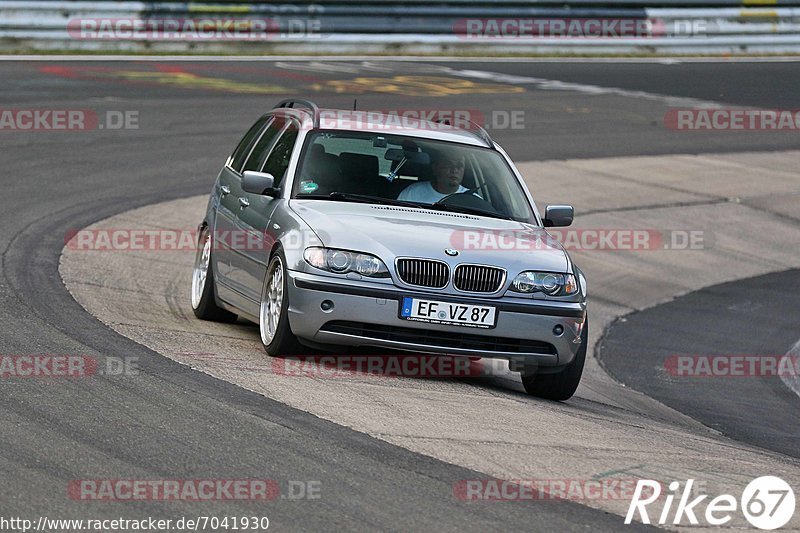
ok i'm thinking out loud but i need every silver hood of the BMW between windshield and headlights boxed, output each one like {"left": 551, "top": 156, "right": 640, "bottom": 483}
{"left": 290, "top": 200, "right": 569, "bottom": 275}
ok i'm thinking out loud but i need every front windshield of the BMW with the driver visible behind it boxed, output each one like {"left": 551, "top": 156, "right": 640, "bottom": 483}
{"left": 292, "top": 131, "right": 536, "bottom": 223}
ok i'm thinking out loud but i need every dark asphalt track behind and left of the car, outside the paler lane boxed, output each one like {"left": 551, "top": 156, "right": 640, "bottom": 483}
{"left": 0, "top": 61, "right": 799, "bottom": 531}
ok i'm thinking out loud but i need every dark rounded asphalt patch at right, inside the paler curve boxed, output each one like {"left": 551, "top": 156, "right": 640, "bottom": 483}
{"left": 597, "top": 270, "right": 800, "bottom": 457}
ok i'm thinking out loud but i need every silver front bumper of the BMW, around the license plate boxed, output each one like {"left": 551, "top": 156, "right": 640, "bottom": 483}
{"left": 287, "top": 271, "right": 586, "bottom": 367}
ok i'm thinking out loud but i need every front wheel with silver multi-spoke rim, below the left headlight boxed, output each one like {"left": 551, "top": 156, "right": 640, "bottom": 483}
{"left": 258, "top": 250, "right": 301, "bottom": 357}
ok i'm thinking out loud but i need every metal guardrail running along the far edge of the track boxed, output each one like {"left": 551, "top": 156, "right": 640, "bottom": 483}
{"left": 0, "top": 0, "right": 800, "bottom": 53}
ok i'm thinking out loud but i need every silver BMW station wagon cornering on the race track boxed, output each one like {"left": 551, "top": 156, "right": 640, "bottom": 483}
{"left": 191, "top": 99, "right": 588, "bottom": 400}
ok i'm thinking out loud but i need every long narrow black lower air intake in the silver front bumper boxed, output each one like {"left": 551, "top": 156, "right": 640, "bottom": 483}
{"left": 321, "top": 320, "right": 557, "bottom": 355}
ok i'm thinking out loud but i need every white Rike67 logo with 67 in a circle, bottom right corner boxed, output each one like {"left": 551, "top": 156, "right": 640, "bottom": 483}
{"left": 625, "top": 476, "right": 795, "bottom": 530}
